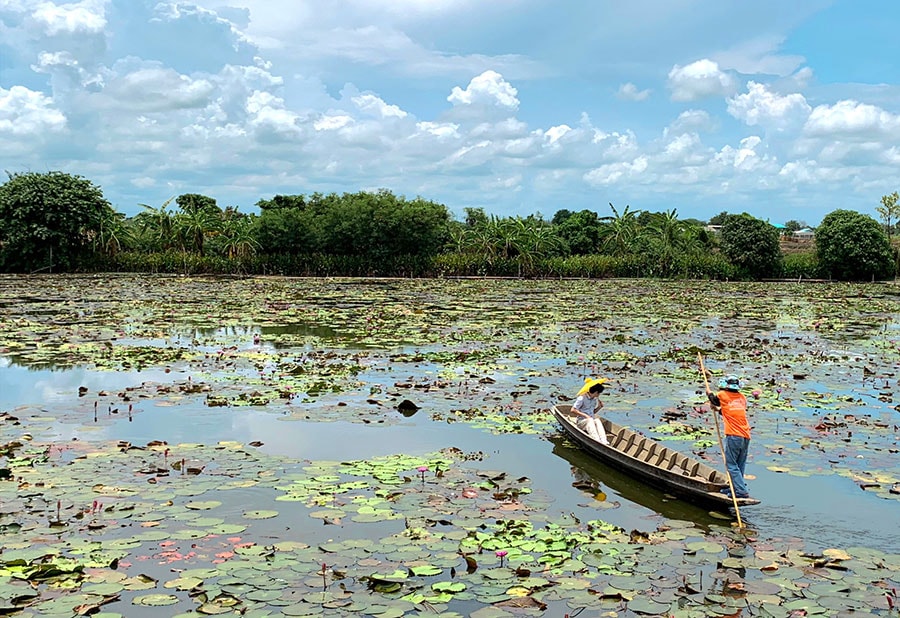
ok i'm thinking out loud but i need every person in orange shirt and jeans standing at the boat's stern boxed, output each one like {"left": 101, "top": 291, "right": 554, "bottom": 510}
{"left": 706, "top": 376, "right": 750, "bottom": 498}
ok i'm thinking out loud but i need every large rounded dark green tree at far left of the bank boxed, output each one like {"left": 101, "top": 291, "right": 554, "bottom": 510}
{"left": 0, "top": 171, "right": 113, "bottom": 272}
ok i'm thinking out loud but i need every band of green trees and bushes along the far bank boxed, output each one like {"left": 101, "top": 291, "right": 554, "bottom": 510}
{"left": 0, "top": 171, "right": 900, "bottom": 280}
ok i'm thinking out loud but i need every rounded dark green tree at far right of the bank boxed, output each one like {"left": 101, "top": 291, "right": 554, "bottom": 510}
{"left": 816, "top": 210, "right": 894, "bottom": 281}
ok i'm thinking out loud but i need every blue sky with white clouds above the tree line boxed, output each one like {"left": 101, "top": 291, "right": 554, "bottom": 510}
{"left": 0, "top": 0, "right": 900, "bottom": 225}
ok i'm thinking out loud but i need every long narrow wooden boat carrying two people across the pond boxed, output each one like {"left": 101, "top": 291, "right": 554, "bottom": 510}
{"left": 552, "top": 404, "right": 759, "bottom": 507}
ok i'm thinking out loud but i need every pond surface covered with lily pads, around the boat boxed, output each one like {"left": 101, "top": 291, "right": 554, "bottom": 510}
{"left": 0, "top": 276, "right": 900, "bottom": 616}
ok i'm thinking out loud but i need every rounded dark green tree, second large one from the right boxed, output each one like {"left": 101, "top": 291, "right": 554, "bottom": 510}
{"left": 721, "top": 213, "right": 784, "bottom": 279}
